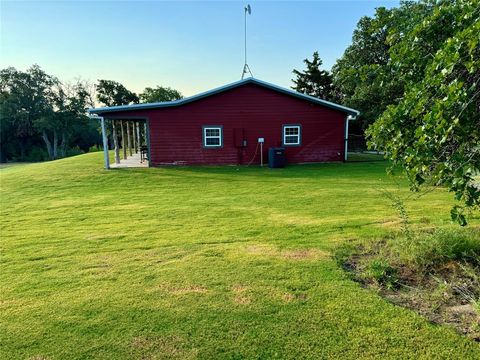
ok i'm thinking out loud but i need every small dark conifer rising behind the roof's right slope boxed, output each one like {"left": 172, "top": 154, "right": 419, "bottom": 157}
{"left": 292, "top": 51, "right": 339, "bottom": 101}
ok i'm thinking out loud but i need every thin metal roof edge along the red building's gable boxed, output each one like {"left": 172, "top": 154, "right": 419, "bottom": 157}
{"left": 88, "top": 77, "right": 360, "bottom": 117}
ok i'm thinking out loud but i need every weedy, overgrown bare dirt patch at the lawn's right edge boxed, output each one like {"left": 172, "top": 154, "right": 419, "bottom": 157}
{"left": 337, "top": 230, "right": 480, "bottom": 341}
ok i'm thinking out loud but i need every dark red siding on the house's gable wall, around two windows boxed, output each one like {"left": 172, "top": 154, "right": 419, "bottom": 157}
{"left": 106, "top": 84, "right": 346, "bottom": 166}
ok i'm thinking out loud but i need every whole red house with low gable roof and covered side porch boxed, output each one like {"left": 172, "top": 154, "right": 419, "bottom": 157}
{"left": 89, "top": 78, "right": 359, "bottom": 167}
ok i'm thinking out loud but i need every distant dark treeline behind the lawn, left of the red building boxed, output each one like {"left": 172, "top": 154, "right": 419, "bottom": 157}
{"left": 0, "top": 65, "right": 182, "bottom": 162}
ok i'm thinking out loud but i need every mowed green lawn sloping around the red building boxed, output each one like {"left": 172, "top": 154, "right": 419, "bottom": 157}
{"left": 0, "top": 153, "right": 480, "bottom": 359}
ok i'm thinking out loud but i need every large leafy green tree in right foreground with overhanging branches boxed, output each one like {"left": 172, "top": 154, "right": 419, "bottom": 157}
{"left": 367, "top": 0, "right": 480, "bottom": 225}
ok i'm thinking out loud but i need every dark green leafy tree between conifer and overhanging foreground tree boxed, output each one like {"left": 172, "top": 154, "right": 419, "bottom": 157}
{"left": 332, "top": 2, "right": 431, "bottom": 132}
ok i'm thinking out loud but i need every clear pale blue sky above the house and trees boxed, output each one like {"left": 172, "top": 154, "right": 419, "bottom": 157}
{"left": 0, "top": 0, "right": 398, "bottom": 96}
